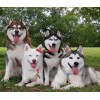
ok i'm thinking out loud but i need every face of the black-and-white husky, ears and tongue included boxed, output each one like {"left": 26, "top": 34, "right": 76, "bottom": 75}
{"left": 44, "top": 31, "right": 61, "bottom": 53}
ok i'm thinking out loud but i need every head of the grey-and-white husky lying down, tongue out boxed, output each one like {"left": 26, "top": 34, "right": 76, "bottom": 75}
{"left": 61, "top": 46, "right": 84, "bottom": 75}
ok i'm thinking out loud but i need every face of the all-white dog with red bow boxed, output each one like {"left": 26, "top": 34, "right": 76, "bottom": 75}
{"left": 24, "top": 44, "right": 43, "bottom": 68}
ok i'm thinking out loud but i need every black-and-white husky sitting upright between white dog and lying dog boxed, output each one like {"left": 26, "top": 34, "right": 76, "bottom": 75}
{"left": 43, "top": 31, "right": 62, "bottom": 85}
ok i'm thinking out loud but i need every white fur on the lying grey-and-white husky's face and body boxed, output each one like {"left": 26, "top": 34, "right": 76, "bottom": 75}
{"left": 51, "top": 46, "right": 100, "bottom": 89}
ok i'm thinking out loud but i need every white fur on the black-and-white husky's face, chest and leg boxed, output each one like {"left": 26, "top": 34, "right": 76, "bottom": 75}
{"left": 44, "top": 31, "right": 62, "bottom": 85}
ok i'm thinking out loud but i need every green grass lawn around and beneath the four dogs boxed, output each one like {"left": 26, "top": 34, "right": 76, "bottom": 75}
{"left": 0, "top": 48, "right": 100, "bottom": 92}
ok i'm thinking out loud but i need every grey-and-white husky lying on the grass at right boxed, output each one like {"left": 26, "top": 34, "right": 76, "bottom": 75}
{"left": 51, "top": 46, "right": 100, "bottom": 89}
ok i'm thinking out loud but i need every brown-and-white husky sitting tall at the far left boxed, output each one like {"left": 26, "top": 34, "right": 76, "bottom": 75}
{"left": 2, "top": 20, "right": 31, "bottom": 81}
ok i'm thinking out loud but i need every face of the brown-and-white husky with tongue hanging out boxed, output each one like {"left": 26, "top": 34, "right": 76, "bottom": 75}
{"left": 7, "top": 21, "right": 27, "bottom": 44}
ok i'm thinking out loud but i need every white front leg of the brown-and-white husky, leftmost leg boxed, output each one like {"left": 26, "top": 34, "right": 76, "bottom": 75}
{"left": 1, "top": 59, "right": 13, "bottom": 82}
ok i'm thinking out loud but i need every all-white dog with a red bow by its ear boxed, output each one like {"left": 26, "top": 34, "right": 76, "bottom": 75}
{"left": 16, "top": 44, "right": 43, "bottom": 87}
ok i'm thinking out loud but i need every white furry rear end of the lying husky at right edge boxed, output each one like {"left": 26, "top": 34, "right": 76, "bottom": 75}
{"left": 89, "top": 68, "right": 100, "bottom": 85}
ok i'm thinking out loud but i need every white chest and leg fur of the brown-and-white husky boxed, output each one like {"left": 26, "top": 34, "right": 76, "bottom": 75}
{"left": 3, "top": 44, "right": 25, "bottom": 81}
